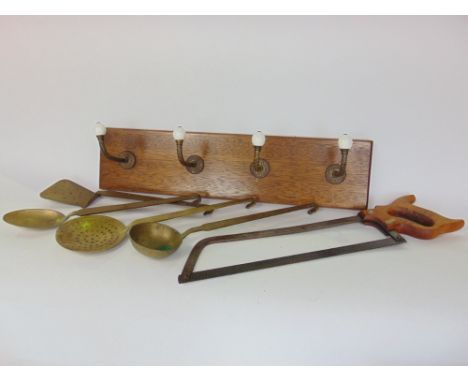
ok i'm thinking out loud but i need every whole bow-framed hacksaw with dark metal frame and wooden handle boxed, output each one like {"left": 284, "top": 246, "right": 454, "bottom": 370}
{"left": 179, "top": 195, "right": 464, "bottom": 283}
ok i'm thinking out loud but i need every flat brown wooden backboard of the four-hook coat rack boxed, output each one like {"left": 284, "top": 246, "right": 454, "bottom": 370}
{"left": 100, "top": 128, "right": 372, "bottom": 209}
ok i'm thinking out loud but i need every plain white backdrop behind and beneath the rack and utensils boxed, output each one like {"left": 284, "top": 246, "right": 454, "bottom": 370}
{"left": 0, "top": 17, "right": 468, "bottom": 364}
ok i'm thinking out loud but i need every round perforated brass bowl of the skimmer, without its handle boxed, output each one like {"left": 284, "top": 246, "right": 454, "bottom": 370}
{"left": 55, "top": 215, "right": 127, "bottom": 252}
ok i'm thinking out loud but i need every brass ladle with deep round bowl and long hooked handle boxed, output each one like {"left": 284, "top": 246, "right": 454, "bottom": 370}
{"left": 129, "top": 203, "right": 317, "bottom": 258}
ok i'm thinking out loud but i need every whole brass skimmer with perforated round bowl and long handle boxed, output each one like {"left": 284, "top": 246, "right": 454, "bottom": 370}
{"left": 55, "top": 198, "right": 255, "bottom": 252}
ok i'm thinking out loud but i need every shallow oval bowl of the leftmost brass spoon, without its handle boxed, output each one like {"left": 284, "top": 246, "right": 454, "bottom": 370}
{"left": 3, "top": 209, "right": 65, "bottom": 229}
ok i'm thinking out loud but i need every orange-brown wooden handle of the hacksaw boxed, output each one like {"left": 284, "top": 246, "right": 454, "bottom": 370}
{"left": 359, "top": 195, "right": 465, "bottom": 239}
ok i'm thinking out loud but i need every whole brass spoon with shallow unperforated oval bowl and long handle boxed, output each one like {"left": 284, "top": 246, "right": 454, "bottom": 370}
{"left": 3, "top": 194, "right": 201, "bottom": 229}
